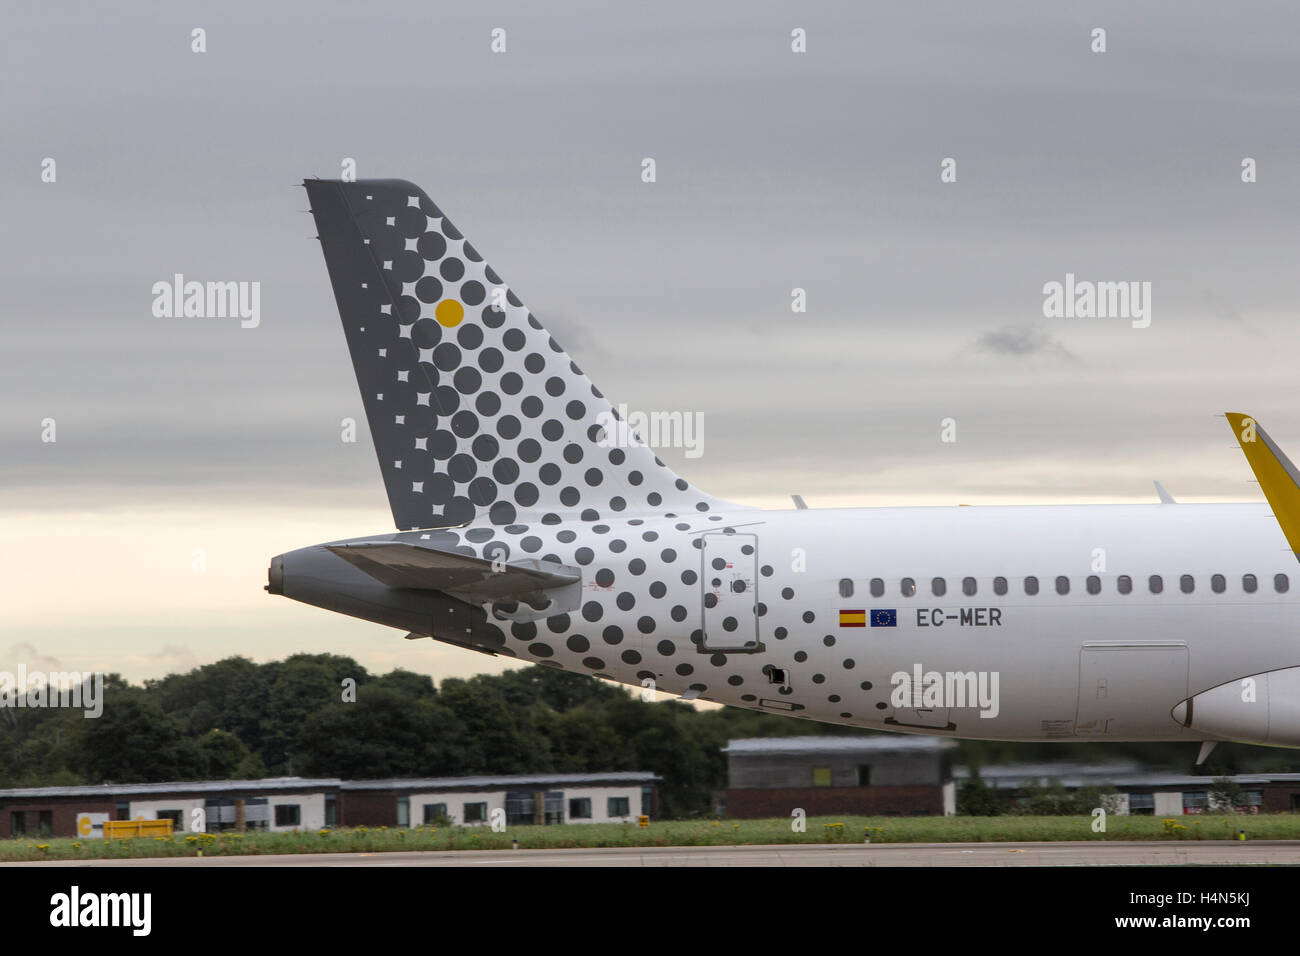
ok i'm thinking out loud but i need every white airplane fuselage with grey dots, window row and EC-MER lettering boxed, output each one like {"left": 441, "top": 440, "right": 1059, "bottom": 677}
{"left": 434, "top": 505, "right": 1300, "bottom": 740}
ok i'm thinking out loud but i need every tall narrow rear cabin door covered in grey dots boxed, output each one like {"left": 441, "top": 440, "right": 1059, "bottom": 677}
{"left": 699, "top": 531, "right": 763, "bottom": 653}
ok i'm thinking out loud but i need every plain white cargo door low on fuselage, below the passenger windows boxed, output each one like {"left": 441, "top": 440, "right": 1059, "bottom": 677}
{"left": 1074, "top": 644, "right": 1187, "bottom": 740}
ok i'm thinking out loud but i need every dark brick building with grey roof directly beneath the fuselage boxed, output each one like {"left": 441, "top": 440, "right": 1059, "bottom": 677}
{"left": 715, "top": 734, "right": 957, "bottom": 819}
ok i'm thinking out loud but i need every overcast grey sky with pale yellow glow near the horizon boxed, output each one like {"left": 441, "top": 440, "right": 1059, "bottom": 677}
{"left": 0, "top": 0, "right": 1300, "bottom": 679}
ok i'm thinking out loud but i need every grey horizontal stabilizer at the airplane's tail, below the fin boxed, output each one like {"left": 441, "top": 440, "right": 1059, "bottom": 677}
{"left": 326, "top": 541, "right": 580, "bottom": 598}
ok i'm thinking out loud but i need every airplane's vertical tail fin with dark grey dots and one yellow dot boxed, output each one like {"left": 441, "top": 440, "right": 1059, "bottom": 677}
{"left": 303, "top": 179, "right": 735, "bottom": 529}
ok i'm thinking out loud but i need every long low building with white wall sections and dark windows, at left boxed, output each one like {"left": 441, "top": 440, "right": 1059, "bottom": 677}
{"left": 0, "top": 773, "right": 659, "bottom": 839}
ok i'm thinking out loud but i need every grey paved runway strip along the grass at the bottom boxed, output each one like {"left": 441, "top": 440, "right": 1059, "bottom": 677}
{"left": 9, "top": 840, "right": 1300, "bottom": 868}
